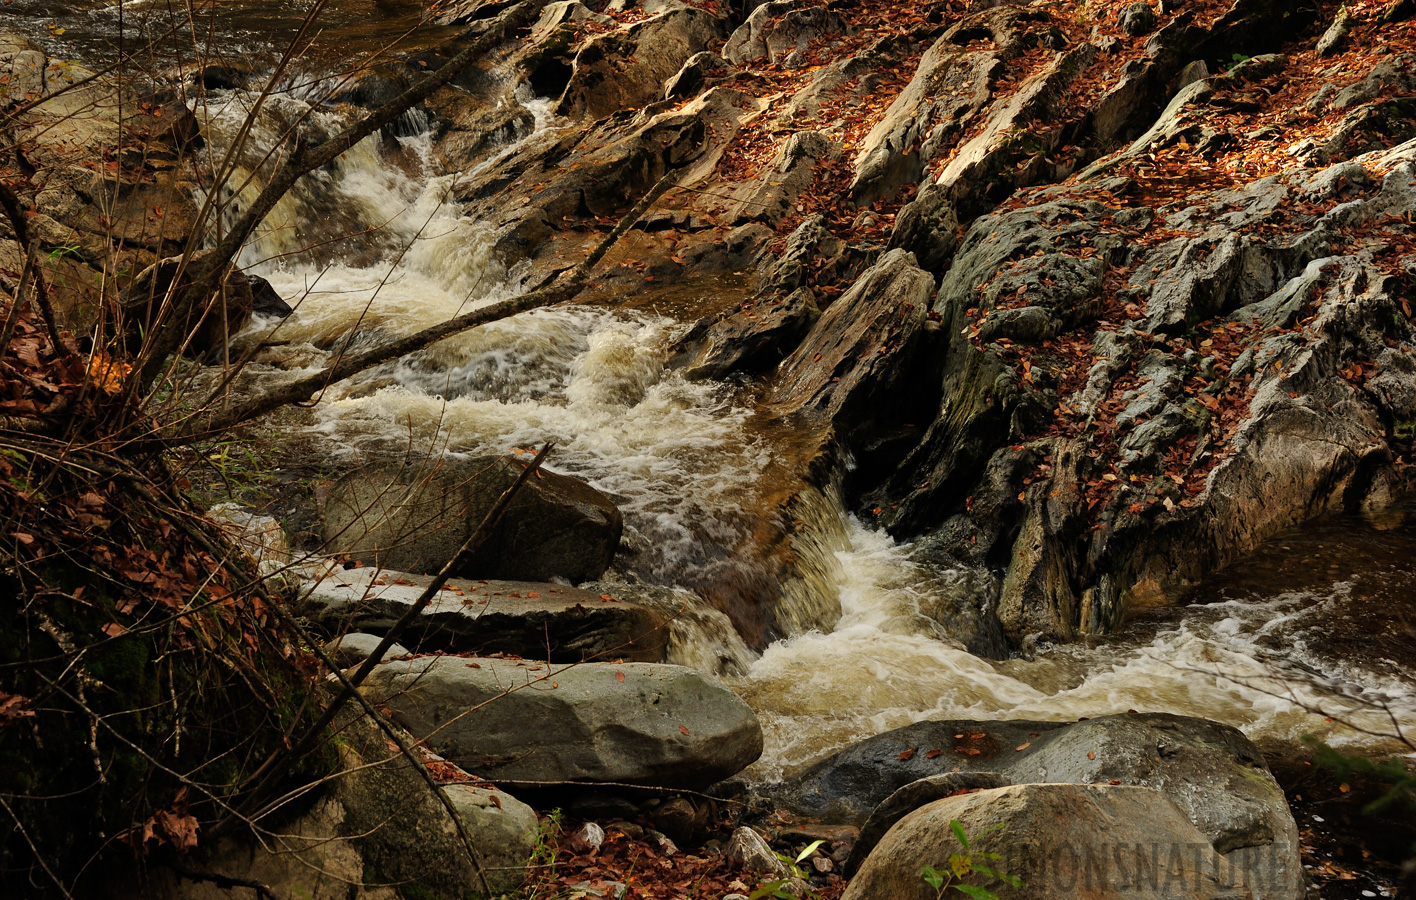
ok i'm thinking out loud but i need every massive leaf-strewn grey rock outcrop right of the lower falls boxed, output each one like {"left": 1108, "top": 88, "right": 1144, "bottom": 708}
{"left": 874, "top": 138, "right": 1416, "bottom": 641}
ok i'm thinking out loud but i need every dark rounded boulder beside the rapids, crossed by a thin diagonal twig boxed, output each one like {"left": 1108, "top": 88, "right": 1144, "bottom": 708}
{"left": 323, "top": 457, "right": 623, "bottom": 582}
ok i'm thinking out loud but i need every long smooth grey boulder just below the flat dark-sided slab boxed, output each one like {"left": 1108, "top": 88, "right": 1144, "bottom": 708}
{"left": 364, "top": 657, "right": 762, "bottom": 790}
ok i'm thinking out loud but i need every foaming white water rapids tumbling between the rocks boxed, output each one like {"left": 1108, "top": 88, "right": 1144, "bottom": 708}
{"left": 199, "top": 85, "right": 1416, "bottom": 780}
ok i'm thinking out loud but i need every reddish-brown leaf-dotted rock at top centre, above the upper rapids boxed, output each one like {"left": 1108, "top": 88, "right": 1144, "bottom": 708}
{"left": 556, "top": 7, "right": 724, "bottom": 119}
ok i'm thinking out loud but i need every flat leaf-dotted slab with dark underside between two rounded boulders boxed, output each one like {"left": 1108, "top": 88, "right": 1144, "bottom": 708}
{"left": 303, "top": 566, "right": 668, "bottom": 662}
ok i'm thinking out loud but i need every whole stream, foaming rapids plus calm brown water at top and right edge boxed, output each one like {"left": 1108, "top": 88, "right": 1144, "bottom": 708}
{"left": 4, "top": 0, "right": 1416, "bottom": 798}
